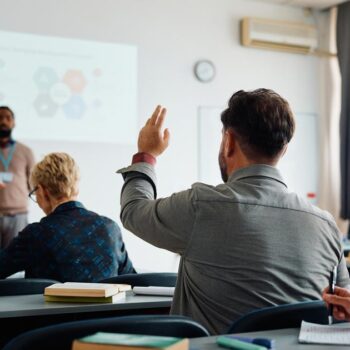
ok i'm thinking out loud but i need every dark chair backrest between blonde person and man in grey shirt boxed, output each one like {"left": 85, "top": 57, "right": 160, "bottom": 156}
{"left": 99, "top": 272, "right": 177, "bottom": 287}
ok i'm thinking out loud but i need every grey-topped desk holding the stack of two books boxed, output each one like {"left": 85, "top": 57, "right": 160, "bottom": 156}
{"left": 0, "top": 291, "right": 172, "bottom": 348}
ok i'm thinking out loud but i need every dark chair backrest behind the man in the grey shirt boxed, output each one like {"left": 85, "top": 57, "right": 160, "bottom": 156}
{"left": 227, "top": 300, "right": 328, "bottom": 333}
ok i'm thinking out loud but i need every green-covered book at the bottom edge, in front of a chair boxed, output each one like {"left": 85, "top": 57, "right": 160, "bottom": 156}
{"left": 72, "top": 332, "right": 189, "bottom": 350}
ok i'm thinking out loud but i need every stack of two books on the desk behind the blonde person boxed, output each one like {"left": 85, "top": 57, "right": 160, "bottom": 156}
{"left": 44, "top": 282, "right": 131, "bottom": 303}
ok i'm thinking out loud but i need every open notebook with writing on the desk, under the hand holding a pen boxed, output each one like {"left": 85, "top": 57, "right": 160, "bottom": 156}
{"left": 299, "top": 321, "right": 350, "bottom": 345}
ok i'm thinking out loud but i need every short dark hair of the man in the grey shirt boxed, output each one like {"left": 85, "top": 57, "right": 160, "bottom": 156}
{"left": 221, "top": 89, "right": 295, "bottom": 160}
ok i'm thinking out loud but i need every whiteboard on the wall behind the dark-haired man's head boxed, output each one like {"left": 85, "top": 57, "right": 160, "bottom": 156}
{"left": 198, "top": 107, "right": 319, "bottom": 204}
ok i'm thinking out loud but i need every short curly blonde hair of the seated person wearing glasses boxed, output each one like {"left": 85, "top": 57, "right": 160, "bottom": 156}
{"left": 30, "top": 153, "right": 79, "bottom": 199}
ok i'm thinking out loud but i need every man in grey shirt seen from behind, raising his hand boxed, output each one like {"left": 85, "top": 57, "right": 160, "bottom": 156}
{"left": 119, "top": 89, "right": 349, "bottom": 334}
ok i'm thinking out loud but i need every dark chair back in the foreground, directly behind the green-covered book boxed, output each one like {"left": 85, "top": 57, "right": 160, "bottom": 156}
{"left": 3, "top": 315, "right": 209, "bottom": 350}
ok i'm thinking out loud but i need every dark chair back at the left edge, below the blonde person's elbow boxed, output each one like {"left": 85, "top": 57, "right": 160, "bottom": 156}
{"left": 0, "top": 278, "right": 59, "bottom": 296}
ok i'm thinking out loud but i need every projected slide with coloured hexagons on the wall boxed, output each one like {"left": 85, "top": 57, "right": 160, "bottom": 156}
{"left": 0, "top": 31, "right": 137, "bottom": 144}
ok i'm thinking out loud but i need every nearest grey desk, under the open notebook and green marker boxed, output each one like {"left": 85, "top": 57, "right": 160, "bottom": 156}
{"left": 190, "top": 328, "right": 349, "bottom": 350}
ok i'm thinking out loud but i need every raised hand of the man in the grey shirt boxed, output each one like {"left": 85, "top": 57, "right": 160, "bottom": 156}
{"left": 138, "top": 106, "right": 170, "bottom": 157}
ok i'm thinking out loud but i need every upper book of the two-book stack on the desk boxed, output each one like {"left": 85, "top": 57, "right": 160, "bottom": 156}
{"left": 44, "top": 282, "right": 131, "bottom": 298}
